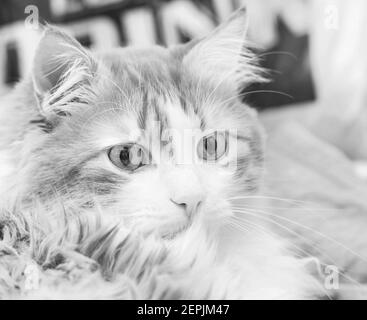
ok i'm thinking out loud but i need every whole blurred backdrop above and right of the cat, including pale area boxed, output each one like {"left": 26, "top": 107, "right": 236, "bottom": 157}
{"left": 0, "top": 0, "right": 367, "bottom": 169}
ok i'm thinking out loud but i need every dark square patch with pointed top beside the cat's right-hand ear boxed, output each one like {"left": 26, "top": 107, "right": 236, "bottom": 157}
{"left": 243, "top": 19, "right": 315, "bottom": 110}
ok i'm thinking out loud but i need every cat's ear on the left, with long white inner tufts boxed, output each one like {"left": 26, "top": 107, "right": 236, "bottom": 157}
{"left": 32, "top": 26, "right": 96, "bottom": 118}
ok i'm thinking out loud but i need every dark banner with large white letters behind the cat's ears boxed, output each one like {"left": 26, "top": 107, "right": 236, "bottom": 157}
{"left": 0, "top": 0, "right": 315, "bottom": 109}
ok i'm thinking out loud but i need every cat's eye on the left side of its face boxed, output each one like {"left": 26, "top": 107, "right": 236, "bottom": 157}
{"left": 108, "top": 143, "right": 149, "bottom": 171}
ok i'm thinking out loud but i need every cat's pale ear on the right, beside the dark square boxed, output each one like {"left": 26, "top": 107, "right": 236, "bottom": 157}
{"left": 181, "top": 8, "right": 262, "bottom": 88}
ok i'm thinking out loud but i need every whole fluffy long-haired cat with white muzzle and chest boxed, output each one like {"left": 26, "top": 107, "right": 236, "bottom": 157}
{"left": 0, "top": 9, "right": 323, "bottom": 299}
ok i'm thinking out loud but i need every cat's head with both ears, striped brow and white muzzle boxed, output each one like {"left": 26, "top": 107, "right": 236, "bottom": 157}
{"left": 12, "top": 10, "right": 263, "bottom": 236}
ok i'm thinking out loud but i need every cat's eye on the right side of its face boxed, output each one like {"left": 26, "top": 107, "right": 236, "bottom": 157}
{"left": 197, "top": 131, "right": 228, "bottom": 161}
